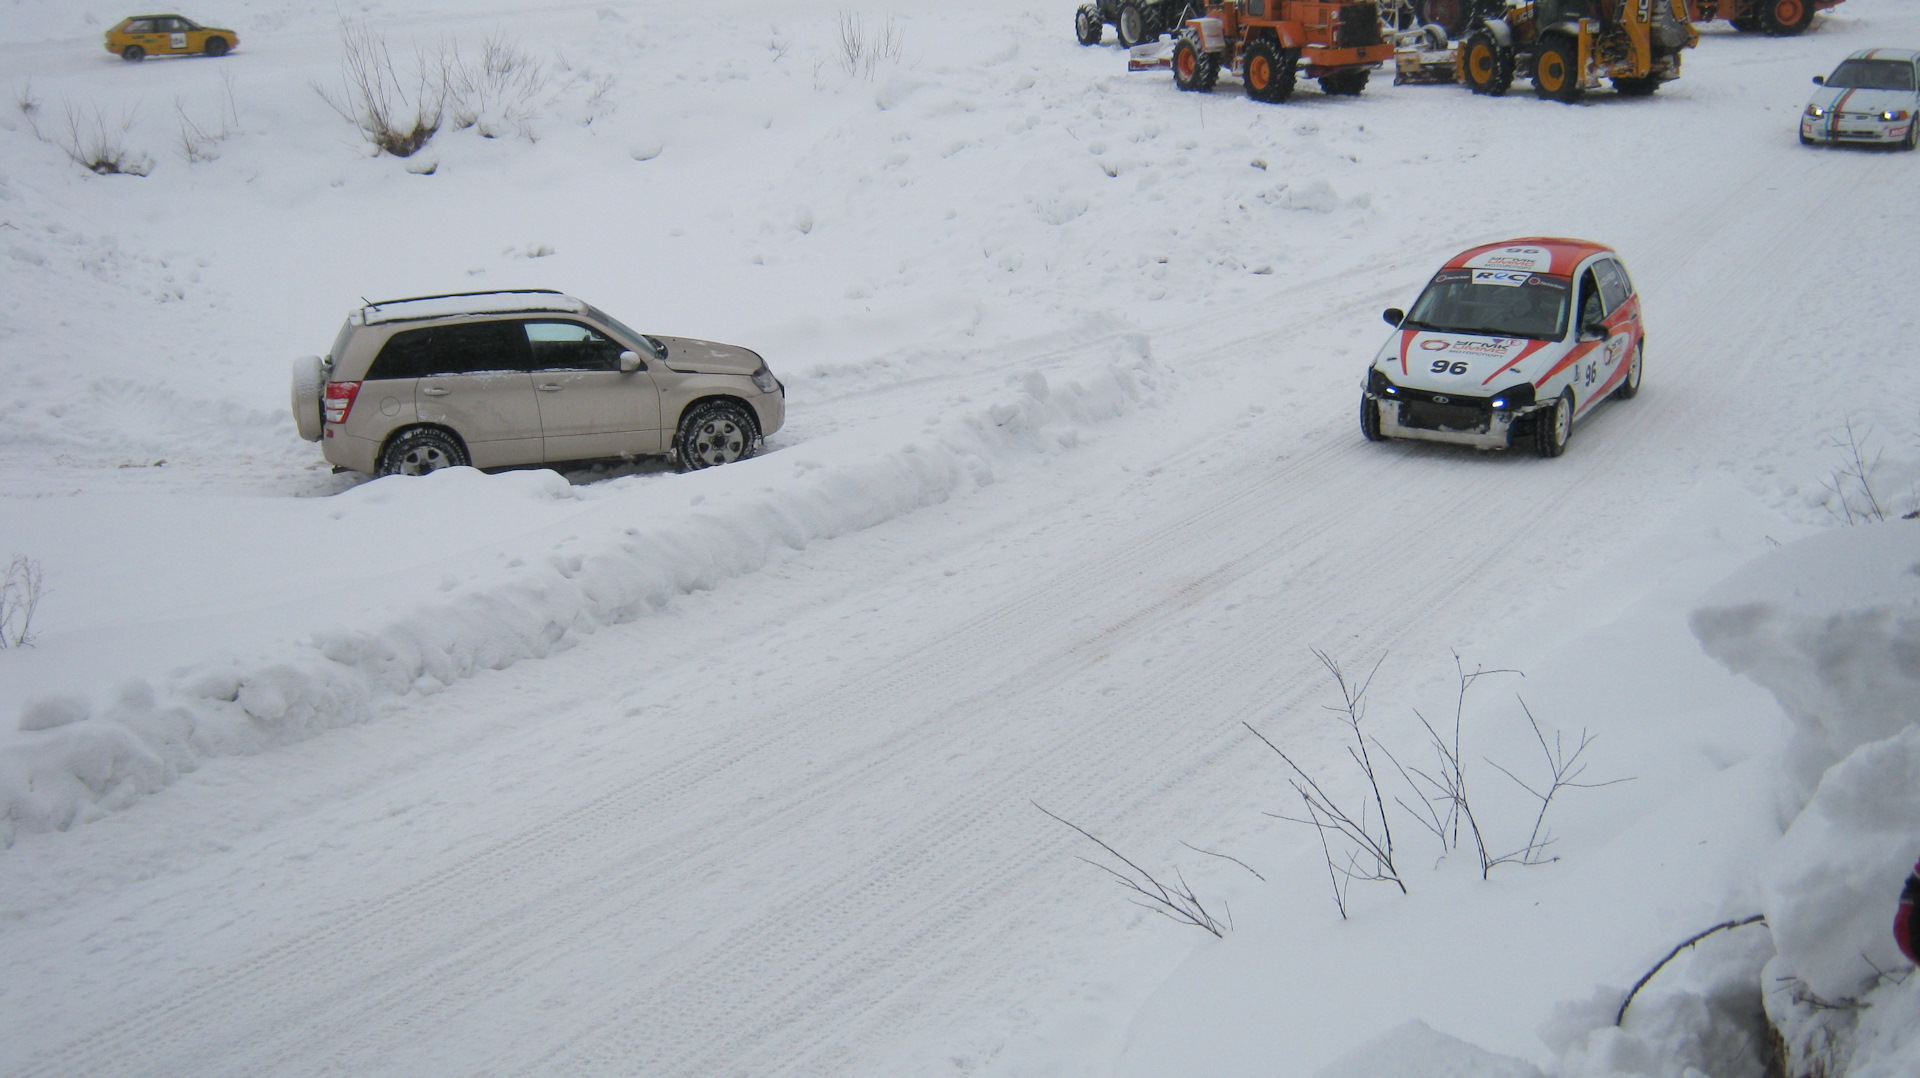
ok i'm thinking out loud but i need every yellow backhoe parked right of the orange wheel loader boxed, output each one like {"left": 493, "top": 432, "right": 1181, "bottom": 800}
{"left": 1457, "top": 0, "right": 1699, "bottom": 104}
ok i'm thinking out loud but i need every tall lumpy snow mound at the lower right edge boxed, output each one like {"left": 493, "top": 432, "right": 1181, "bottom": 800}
{"left": 1666, "top": 521, "right": 1920, "bottom": 1074}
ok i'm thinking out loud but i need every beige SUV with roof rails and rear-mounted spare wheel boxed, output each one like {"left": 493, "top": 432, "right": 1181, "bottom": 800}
{"left": 294, "top": 288, "right": 787, "bottom": 475}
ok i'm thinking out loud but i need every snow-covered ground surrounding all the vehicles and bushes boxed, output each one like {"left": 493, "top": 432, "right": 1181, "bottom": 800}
{"left": 0, "top": 0, "right": 1920, "bottom": 1078}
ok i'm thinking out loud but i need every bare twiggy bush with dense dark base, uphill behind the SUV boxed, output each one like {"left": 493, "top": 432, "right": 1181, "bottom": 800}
{"left": 313, "top": 21, "right": 447, "bottom": 158}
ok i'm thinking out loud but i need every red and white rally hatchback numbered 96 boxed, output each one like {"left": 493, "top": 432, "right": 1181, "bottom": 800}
{"left": 1359, "top": 236, "right": 1645, "bottom": 457}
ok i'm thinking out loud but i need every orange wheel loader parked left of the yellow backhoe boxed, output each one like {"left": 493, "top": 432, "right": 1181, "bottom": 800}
{"left": 1127, "top": 0, "right": 1394, "bottom": 104}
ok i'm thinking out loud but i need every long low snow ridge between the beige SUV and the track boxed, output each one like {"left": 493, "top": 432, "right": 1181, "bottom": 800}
{"left": 0, "top": 345, "right": 1160, "bottom": 845}
